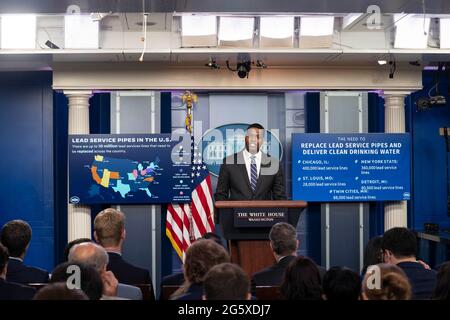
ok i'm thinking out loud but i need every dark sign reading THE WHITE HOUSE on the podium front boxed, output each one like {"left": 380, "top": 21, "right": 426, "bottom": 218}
{"left": 234, "top": 208, "right": 288, "bottom": 228}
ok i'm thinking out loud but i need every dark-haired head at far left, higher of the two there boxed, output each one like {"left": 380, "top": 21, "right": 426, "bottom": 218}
{"left": 1, "top": 220, "right": 31, "bottom": 258}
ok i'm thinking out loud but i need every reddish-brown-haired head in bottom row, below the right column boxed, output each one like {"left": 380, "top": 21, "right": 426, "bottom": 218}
{"left": 362, "top": 263, "right": 411, "bottom": 300}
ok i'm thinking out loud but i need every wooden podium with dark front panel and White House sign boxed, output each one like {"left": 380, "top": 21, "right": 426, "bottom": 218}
{"left": 215, "top": 200, "right": 307, "bottom": 276}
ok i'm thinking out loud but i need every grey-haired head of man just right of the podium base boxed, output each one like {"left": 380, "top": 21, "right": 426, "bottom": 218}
{"left": 269, "top": 222, "right": 297, "bottom": 256}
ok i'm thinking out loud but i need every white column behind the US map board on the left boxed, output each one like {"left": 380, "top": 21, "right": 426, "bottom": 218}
{"left": 64, "top": 90, "right": 92, "bottom": 241}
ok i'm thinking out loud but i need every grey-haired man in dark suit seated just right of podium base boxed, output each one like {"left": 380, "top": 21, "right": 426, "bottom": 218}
{"left": 252, "top": 222, "right": 325, "bottom": 294}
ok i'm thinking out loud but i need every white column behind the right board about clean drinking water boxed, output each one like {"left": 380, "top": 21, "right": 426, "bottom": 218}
{"left": 384, "top": 91, "right": 410, "bottom": 231}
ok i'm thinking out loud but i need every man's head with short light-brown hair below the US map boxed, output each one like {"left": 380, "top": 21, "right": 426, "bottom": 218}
{"left": 94, "top": 208, "right": 125, "bottom": 247}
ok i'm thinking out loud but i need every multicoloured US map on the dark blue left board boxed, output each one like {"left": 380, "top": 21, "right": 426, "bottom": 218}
{"left": 89, "top": 155, "right": 160, "bottom": 199}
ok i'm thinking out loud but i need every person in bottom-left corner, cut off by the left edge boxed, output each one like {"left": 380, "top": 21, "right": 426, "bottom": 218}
{"left": 0, "top": 244, "right": 36, "bottom": 300}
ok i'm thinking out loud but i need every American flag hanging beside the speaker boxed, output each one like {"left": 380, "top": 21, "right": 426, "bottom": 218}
{"left": 166, "top": 135, "right": 214, "bottom": 261}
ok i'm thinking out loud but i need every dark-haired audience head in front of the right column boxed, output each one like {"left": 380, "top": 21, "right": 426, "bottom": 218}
{"left": 381, "top": 228, "right": 417, "bottom": 264}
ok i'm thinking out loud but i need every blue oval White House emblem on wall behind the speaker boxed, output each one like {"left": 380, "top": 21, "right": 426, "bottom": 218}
{"left": 201, "top": 123, "right": 283, "bottom": 176}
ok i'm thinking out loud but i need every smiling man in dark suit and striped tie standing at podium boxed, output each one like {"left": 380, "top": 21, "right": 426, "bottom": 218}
{"left": 214, "top": 123, "right": 286, "bottom": 201}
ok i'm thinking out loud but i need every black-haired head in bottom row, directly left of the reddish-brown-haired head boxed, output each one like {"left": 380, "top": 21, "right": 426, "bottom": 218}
{"left": 322, "top": 267, "right": 361, "bottom": 300}
